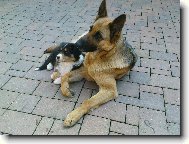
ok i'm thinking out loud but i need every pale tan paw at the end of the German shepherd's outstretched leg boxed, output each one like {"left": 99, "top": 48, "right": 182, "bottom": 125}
{"left": 64, "top": 107, "right": 84, "bottom": 127}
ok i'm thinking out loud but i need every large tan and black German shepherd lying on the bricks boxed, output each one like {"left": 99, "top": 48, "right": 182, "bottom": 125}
{"left": 61, "top": 0, "right": 137, "bottom": 126}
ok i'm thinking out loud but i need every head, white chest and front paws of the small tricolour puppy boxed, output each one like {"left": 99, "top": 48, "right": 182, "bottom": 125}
{"left": 51, "top": 43, "right": 84, "bottom": 84}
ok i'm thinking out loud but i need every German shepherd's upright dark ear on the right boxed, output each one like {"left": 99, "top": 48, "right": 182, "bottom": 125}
{"left": 109, "top": 14, "right": 126, "bottom": 43}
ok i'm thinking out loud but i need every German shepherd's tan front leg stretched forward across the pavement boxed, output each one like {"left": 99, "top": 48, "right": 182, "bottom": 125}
{"left": 64, "top": 74, "right": 118, "bottom": 127}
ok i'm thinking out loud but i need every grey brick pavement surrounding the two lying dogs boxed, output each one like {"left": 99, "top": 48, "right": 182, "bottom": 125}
{"left": 0, "top": 0, "right": 180, "bottom": 135}
